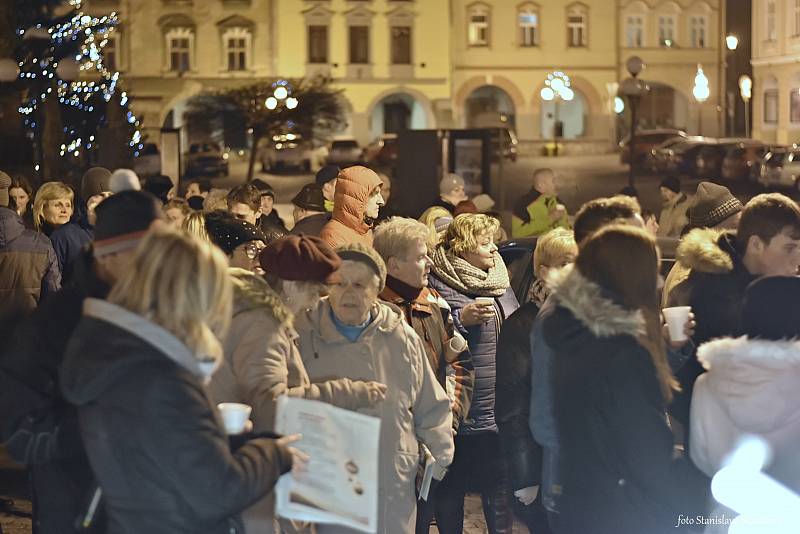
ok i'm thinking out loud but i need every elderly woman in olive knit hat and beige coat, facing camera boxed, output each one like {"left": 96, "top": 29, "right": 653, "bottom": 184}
{"left": 296, "top": 244, "right": 454, "bottom": 534}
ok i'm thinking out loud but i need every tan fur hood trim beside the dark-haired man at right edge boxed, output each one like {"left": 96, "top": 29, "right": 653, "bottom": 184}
{"left": 676, "top": 228, "right": 735, "bottom": 274}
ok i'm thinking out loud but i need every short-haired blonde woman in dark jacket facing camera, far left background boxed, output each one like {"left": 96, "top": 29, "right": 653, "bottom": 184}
{"left": 33, "top": 182, "right": 94, "bottom": 282}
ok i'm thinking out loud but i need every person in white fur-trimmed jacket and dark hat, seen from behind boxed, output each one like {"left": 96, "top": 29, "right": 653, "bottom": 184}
{"left": 689, "top": 276, "right": 800, "bottom": 531}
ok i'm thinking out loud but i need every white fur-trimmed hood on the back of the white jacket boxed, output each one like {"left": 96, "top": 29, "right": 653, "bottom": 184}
{"left": 697, "top": 337, "right": 800, "bottom": 433}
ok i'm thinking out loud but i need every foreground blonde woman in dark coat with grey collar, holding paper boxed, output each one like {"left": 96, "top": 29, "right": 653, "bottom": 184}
{"left": 61, "top": 229, "right": 305, "bottom": 534}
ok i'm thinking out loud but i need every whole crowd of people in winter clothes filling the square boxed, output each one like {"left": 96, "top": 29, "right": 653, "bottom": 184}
{"left": 0, "top": 162, "right": 800, "bottom": 534}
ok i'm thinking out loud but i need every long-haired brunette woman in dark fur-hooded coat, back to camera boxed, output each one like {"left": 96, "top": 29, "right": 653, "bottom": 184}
{"left": 541, "top": 226, "right": 708, "bottom": 534}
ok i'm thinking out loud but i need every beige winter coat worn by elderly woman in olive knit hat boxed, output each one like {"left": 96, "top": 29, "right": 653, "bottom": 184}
{"left": 296, "top": 299, "right": 453, "bottom": 534}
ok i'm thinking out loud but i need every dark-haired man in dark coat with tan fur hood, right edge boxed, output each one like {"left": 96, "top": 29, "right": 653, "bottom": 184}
{"left": 668, "top": 193, "right": 800, "bottom": 423}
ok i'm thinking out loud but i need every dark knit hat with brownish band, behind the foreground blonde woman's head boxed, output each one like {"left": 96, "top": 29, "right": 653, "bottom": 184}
{"left": 92, "top": 191, "right": 164, "bottom": 257}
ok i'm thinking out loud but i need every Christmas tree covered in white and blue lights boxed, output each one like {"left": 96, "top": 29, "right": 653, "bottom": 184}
{"left": 8, "top": 0, "right": 142, "bottom": 179}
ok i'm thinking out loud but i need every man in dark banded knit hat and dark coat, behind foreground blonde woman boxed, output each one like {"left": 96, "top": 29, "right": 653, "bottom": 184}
{"left": 0, "top": 191, "right": 162, "bottom": 534}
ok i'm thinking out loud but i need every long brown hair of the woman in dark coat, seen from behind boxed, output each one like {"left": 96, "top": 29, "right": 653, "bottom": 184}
{"left": 575, "top": 225, "right": 679, "bottom": 403}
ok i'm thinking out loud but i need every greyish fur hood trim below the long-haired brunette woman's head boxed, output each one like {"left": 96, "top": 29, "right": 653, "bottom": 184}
{"left": 548, "top": 267, "right": 646, "bottom": 337}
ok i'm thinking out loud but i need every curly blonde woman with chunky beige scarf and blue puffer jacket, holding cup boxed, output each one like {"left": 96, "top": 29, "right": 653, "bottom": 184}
{"left": 430, "top": 213, "right": 519, "bottom": 534}
